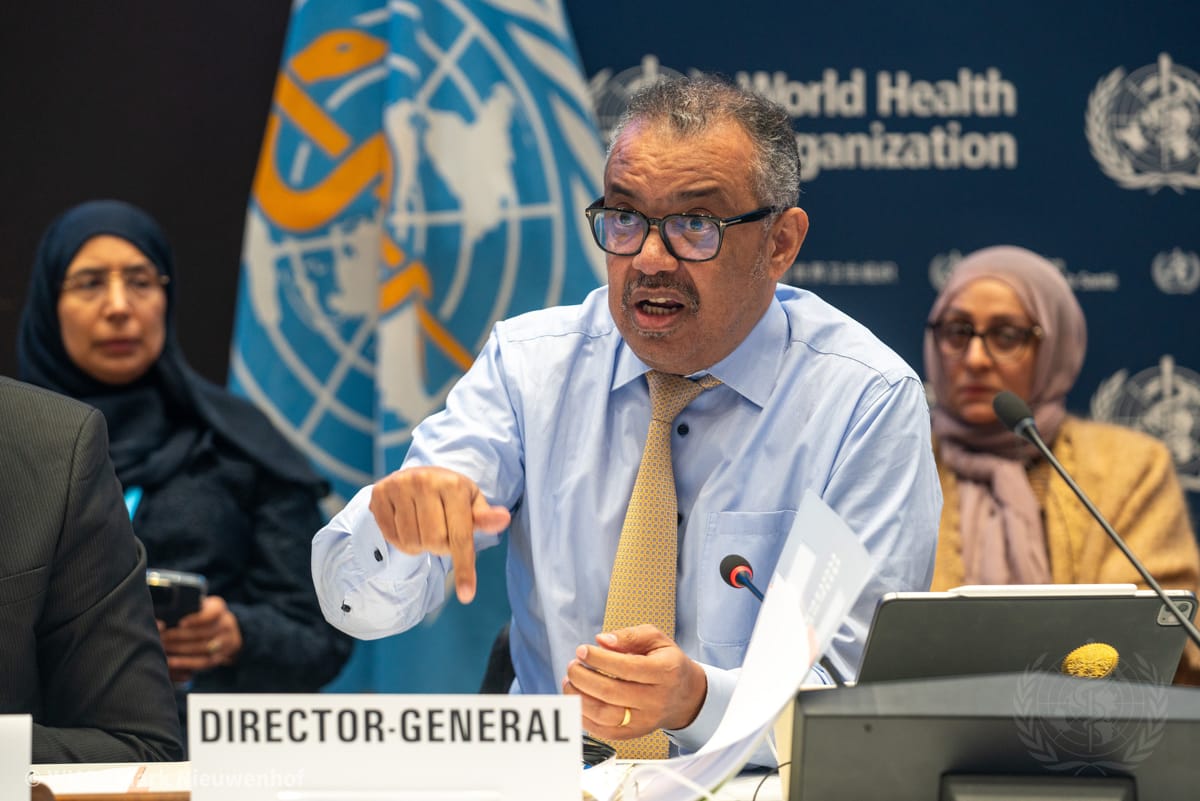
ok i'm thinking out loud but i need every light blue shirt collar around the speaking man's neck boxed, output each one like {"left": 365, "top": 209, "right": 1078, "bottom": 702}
{"left": 611, "top": 292, "right": 790, "bottom": 408}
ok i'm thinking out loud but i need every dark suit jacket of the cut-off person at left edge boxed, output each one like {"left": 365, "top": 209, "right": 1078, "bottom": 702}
{"left": 0, "top": 378, "right": 181, "bottom": 763}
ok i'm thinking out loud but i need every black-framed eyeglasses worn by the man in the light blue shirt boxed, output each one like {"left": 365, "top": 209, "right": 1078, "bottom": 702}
{"left": 583, "top": 198, "right": 781, "bottom": 261}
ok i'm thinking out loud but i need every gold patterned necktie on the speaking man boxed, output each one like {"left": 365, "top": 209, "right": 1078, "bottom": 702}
{"left": 604, "top": 371, "right": 720, "bottom": 759}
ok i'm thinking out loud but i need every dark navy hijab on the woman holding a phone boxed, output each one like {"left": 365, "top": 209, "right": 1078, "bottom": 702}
{"left": 17, "top": 200, "right": 326, "bottom": 495}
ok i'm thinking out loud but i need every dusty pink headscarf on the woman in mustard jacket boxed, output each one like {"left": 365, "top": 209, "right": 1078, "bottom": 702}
{"left": 925, "top": 246, "right": 1087, "bottom": 584}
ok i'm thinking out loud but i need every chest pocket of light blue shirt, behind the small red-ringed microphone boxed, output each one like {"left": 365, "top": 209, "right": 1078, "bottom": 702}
{"left": 696, "top": 510, "right": 796, "bottom": 652}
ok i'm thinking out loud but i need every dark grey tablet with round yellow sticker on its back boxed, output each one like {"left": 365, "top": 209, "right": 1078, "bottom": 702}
{"left": 858, "top": 584, "right": 1196, "bottom": 685}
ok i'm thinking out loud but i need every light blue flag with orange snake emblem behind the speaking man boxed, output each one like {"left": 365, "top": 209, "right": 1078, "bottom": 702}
{"left": 230, "top": 0, "right": 604, "bottom": 692}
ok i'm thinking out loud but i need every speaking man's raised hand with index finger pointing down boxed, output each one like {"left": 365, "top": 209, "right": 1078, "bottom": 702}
{"left": 371, "top": 468, "right": 511, "bottom": 603}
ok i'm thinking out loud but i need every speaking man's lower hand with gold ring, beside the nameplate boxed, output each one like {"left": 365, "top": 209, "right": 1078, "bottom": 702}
{"left": 563, "top": 625, "right": 708, "bottom": 740}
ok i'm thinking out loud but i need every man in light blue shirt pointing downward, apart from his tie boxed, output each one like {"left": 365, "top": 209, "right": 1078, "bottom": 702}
{"left": 313, "top": 78, "right": 941, "bottom": 752}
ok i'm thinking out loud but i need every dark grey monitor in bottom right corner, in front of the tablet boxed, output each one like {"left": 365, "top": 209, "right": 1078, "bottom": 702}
{"left": 787, "top": 671, "right": 1200, "bottom": 801}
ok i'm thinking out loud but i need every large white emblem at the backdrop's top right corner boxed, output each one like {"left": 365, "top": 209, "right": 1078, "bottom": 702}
{"left": 1085, "top": 53, "right": 1200, "bottom": 194}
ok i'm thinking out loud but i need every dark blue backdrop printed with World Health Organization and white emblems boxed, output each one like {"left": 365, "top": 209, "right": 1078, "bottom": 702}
{"left": 566, "top": 0, "right": 1200, "bottom": 517}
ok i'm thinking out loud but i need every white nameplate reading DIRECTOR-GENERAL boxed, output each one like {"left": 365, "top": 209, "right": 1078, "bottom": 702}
{"left": 188, "top": 693, "right": 582, "bottom": 801}
